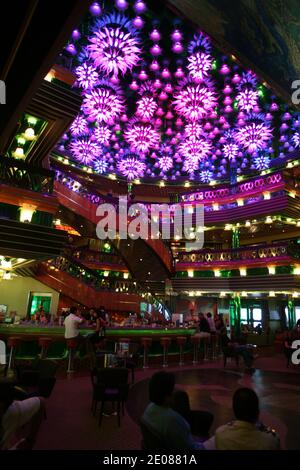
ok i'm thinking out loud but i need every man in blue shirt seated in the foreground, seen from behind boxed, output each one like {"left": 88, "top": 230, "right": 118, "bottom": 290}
{"left": 142, "top": 372, "right": 203, "bottom": 450}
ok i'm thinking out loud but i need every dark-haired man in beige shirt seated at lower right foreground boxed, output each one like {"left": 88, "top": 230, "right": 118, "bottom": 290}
{"left": 204, "top": 388, "right": 280, "bottom": 450}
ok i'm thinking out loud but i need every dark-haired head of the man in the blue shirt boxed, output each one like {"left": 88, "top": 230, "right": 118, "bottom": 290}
{"left": 149, "top": 371, "right": 175, "bottom": 406}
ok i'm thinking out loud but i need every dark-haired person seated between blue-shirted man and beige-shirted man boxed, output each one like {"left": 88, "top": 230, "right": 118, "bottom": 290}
{"left": 171, "top": 390, "right": 214, "bottom": 439}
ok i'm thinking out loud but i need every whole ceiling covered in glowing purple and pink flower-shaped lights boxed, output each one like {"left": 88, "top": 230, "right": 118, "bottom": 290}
{"left": 56, "top": 0, "right": 300, "bottom": 183}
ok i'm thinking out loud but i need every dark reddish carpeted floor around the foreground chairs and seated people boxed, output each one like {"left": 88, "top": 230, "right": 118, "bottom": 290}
{"left": 35, "top": 357, "right": 300, "bottom": 450}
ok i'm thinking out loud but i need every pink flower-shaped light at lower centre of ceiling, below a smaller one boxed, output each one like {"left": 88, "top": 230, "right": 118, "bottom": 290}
{"left": 124, "top": 123, "right": 160, "bottom": 153}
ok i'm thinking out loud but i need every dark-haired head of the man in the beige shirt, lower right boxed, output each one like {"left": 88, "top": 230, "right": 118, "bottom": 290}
{"left": 232, "top": 387, "right": 259, "bottom": 423}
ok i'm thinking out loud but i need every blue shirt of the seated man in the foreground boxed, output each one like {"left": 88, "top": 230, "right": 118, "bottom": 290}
{"left": 142, "top": 403, "right": 204, "bottom": 450}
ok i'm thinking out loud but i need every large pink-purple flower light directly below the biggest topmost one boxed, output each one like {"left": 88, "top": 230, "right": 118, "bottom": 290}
{"left": 82, "top": 81, "right": 124, "bottom": 124}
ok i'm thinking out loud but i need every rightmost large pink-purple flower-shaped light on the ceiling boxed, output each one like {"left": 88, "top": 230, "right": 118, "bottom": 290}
{"left": 235, "top": 122, "right": 272, "bottom": 153}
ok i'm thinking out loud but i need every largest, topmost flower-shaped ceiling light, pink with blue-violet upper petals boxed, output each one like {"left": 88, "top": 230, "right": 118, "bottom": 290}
{"left": 87, "top": 14, "right": 141, "bottom": 76}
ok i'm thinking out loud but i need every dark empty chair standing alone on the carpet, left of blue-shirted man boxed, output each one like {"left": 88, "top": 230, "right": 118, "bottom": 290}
{"left": 91, "top": 367, "right": 128, "bottom": 426}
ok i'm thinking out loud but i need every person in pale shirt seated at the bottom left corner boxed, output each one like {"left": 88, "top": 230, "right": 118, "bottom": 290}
{"left": 0, "top": 384, "right": 45, "bottom": 450}
